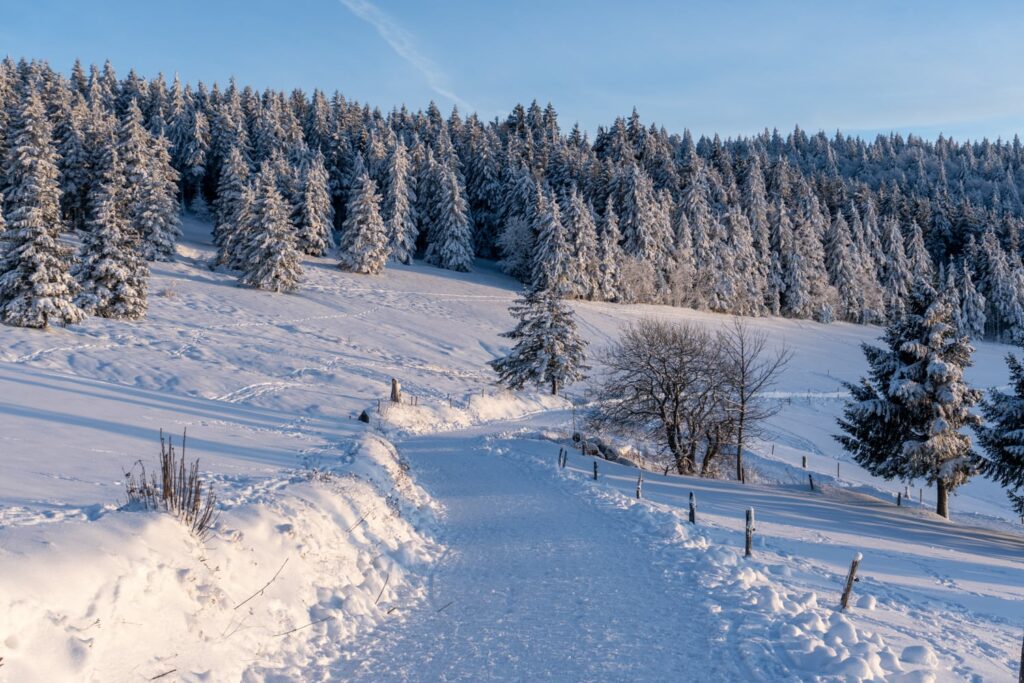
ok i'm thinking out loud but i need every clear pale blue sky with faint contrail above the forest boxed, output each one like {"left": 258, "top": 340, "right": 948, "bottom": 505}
{"left": 0, "top": 0, "right": 1024, "bottom": 138}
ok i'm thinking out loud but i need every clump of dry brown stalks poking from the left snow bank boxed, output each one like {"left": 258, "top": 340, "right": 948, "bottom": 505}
{"left": 125, "top": 430, "right": 217, "bottom": 539}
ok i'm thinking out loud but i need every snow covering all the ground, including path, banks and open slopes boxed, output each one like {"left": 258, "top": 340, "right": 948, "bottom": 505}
{"left": 0, "top": 221, "right": 1024, "bottom": 681}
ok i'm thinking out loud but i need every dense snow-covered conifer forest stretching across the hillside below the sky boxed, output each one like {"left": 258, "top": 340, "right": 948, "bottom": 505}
{"left": 0, "top": 58, "right": 1024, "bottom": 340}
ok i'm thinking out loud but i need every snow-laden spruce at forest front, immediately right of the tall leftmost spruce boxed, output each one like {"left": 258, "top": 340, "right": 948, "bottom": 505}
{"left": 75, "top": 146, "right": 150, "bottom": 319}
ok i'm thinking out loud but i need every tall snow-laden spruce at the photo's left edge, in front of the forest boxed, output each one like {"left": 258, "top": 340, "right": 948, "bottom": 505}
{"left": 0, "top": 84, "right": 85, "bottom": 328}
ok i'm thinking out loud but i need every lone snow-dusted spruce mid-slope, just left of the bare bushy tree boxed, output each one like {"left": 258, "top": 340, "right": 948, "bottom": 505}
{"left": 489, "top": 290, "right": 587, "bottom": 395}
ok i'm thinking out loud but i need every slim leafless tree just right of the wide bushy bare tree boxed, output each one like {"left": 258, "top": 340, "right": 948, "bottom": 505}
{"left": 718, "top": 317, "right": 793, "bottom": 480}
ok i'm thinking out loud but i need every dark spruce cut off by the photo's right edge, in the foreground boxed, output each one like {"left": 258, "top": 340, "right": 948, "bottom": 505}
{"left": 975, "top": 353, "right": 1024, "bottom": 516}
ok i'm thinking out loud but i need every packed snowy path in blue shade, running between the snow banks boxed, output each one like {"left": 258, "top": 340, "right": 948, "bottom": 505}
{"left": 324, "top": 435, "right": 736, "bottom": 681}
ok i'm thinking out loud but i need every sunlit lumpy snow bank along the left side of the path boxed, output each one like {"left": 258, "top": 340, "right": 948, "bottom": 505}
{"left": 0, "top": 435, "right": 437, "bottom": 681}
